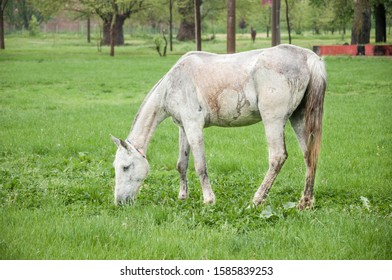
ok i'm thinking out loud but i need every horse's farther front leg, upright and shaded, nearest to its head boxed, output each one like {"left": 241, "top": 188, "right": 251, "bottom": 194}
{"left": 177, "top": 127, "right": 190, "bottom": 200}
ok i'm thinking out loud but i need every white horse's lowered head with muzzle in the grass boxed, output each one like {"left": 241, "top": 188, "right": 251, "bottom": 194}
{"left": 112, "top": 136, "right": 149, "bottom": 205}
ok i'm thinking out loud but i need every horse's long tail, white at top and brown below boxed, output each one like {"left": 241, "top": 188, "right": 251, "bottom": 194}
{"left": 305, "top": 54, "right": 327, "bottom": 172}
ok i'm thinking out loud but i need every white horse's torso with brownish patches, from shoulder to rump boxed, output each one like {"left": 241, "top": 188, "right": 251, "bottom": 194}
{"left": 165, "top": 45, "right": 316, "bottom": 126}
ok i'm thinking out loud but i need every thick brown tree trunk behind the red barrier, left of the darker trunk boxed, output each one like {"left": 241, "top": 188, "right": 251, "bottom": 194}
{"left": 351, "top": 0, "right": 371, "bottom": 45}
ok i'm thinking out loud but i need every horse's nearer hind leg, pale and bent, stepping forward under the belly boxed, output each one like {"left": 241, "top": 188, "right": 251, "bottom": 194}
{"left": 253, "top": 120, "right": 287, "bottom": 206}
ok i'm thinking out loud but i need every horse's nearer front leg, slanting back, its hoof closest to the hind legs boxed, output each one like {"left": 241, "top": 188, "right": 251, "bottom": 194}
{"left": 185, "top": 124, "right": 215, "bottom": 204}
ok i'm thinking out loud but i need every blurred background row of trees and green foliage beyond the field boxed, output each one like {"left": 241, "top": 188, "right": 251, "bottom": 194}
{"left": 0, "top": 0, "right": 392, "bottom": 45}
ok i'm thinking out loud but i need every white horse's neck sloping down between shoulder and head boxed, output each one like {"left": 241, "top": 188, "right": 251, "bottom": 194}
{"left": 127, "top": 81, "right": 167, "bottom": 154}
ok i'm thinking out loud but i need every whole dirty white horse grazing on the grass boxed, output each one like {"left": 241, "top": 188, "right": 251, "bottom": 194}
{"left": 112, "top": 45, "right": 326, "bottom": 209}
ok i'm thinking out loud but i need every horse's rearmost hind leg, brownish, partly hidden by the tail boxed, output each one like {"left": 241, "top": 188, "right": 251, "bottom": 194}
{"left": 290, "top": 107, "right": 316, "bottom": 210}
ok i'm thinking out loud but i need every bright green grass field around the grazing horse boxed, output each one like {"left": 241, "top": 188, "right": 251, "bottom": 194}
{"left": 0, "top": 35, "right": 392, "bottom": 260}
